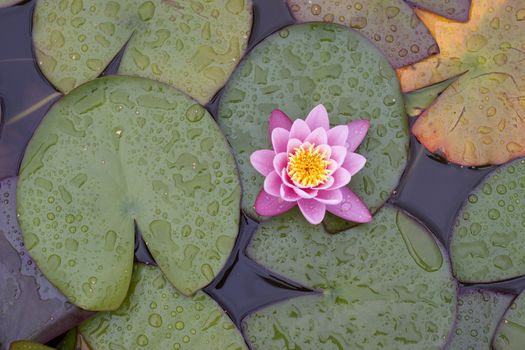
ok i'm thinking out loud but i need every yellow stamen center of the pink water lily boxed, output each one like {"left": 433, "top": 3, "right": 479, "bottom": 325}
{"left": 288, "top": 144, "right": 330, "bottom": 187}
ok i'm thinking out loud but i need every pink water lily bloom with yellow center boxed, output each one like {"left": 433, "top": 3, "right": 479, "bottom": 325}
{"left": 250, "top": 105, "right": 372, "bottom": 225}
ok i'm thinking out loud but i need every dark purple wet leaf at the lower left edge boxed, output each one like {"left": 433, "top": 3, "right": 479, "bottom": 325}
{"left": 0, "top": 178, "right": 90, "bottom": 349}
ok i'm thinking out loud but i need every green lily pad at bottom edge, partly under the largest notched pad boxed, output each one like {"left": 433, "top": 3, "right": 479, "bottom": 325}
{"left": 79, "top": 264, "right": 247, "bottom": 350}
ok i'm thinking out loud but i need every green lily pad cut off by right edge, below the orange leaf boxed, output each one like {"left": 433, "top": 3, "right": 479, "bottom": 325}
{"left": 450, "top": 160, "right": 525, "bottom": 282}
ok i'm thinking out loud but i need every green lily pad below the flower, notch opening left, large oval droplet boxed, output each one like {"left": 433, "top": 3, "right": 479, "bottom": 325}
{"left": 244, "top": 207, "right": 456, "bottom": 350}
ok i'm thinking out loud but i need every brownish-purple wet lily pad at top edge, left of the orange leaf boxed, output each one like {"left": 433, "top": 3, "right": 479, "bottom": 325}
{"left": 287, "top": 0, "right": 439, "bottom": 67}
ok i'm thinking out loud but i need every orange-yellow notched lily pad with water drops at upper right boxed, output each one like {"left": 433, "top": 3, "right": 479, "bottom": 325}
{"left": 399, "top": 0, "right": 525, "bottom": 166}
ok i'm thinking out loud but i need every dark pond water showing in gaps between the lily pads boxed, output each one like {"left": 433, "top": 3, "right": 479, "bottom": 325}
{"left": 0, "top": 0, "right": 525, "bottom": 348}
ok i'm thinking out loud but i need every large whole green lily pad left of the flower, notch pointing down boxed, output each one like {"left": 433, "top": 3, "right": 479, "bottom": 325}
{"left": 17, "top": 76, "right": 240, "bottom": 310}
